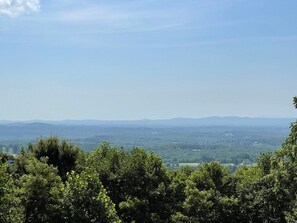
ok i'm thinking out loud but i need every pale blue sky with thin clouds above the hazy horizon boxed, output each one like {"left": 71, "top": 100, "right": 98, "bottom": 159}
{"left": 0, "top": 0, "right": 297, "bottom": 120}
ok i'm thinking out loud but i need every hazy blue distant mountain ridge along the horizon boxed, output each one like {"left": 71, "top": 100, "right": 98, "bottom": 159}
{"left": 0, "top": 116, "right": 296, "bottom": 127}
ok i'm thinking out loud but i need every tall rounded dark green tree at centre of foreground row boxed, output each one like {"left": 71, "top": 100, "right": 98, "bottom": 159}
{"left": 119, "top": 148, "right": 174, "bottom": 222}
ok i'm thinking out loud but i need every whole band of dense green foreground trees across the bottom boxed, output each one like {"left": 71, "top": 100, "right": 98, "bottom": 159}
{"left": 0, "top": 97, "right": 297, "bottom": 223}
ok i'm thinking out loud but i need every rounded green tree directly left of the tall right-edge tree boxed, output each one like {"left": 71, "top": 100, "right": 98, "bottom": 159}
{"left": 234, "top": 148, "right": 294, "bottom": 222}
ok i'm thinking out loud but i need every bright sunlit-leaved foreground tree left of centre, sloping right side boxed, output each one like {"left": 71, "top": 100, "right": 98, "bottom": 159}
{"left": 63, "top": 169, "right": 120, "bottom": 223}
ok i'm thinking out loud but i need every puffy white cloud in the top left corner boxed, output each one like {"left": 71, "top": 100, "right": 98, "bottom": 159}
{"left": 0, "top": 0, "right": 40, "bottom": 17}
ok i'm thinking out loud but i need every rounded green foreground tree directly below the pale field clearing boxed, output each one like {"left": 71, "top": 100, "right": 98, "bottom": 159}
{"left": 173, "top": 162, "right": 239, "bottom": 223}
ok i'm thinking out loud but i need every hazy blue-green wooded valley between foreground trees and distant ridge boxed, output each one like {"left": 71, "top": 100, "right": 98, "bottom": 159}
{"left": 0, "top": 120, "right": 295, "bottom": 166}
